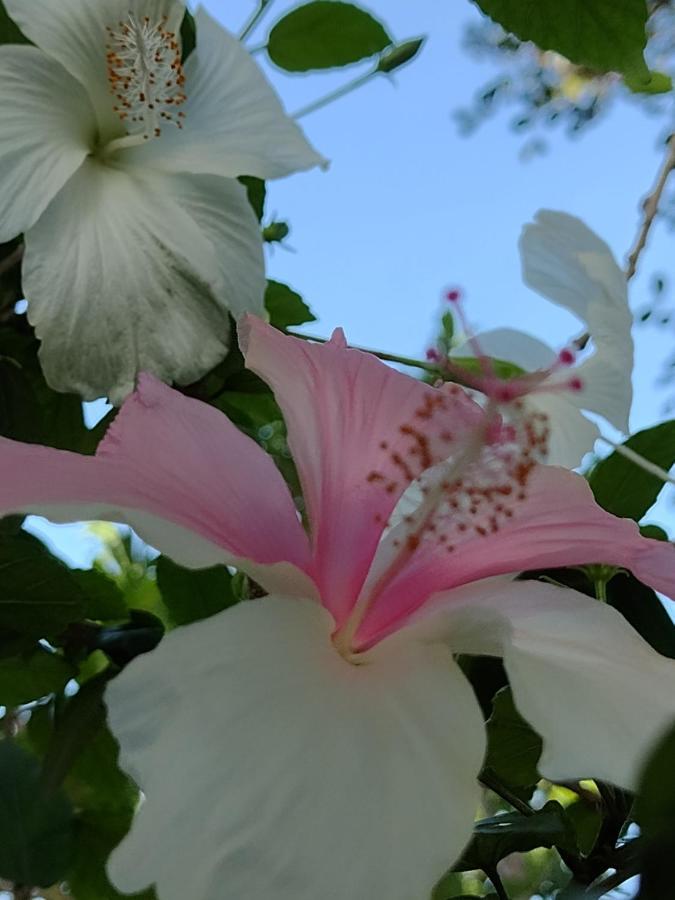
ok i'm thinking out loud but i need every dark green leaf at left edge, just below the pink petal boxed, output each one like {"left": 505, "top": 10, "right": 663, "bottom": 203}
{"left": 0, "top": 531, "right": 86, "bottom": 638}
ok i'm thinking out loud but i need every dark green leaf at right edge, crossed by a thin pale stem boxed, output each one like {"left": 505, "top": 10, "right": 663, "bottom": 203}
{"left": 588, "top": 419, "right": 675, "bottom": 521}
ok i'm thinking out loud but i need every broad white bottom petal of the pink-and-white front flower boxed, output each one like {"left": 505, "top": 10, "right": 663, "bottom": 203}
{"left": 107, "top": 597, "right": 484, "bottom": 900}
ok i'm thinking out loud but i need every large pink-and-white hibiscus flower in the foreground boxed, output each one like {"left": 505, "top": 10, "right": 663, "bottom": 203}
{"left": 0, "top": 316, "right": 675, "bottom": 900}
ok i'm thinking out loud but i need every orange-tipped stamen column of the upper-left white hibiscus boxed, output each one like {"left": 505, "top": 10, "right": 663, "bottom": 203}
{"left": 106, "top": 11, "right": 187, "bottom": 144}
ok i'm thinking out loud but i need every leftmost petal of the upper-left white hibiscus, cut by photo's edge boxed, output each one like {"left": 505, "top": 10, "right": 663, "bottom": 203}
{"left": 0, "top": 44, "right": 96, "bottom": 243}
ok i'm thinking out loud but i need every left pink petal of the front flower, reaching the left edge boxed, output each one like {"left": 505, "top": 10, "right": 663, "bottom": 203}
{"left": 0, "top": 375, "right": 309, "bottom": 592}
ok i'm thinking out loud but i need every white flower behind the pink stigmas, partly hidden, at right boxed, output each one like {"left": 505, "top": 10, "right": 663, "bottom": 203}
{"left": 452, "top": 210, "right": 633, "bottom": 468}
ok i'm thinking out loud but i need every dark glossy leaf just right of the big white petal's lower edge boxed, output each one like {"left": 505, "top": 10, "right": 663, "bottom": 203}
{"left": 453, "top": 800, "right": 577, "bottom": 872}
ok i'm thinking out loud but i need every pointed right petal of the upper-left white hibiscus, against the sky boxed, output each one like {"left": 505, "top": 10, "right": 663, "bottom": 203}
{"left": 122, "top": 8, "right": 326, "bottom": 178}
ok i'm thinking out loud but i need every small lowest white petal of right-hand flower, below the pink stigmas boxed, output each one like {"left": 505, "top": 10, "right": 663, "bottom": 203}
{"left": 525, "top": 391, "right": 600, "bottom": 469}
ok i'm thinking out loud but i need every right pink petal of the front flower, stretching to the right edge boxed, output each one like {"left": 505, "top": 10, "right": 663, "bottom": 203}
{"left": 357, "top": 466, "right": 675, "bottom": 647}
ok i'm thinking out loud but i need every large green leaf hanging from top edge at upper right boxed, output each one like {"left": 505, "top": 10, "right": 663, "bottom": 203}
{"left": 474, "top": 0, "right": 650, "bottom": 85}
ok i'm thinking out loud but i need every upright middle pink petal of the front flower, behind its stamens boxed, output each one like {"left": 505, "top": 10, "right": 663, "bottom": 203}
{"left": 240, "top": 316, "right": 481, "bottom": 626}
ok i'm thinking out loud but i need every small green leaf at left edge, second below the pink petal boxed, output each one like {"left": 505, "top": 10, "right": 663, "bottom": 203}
{"left": 0, "top": 648, "right": 77, "bottom": 707}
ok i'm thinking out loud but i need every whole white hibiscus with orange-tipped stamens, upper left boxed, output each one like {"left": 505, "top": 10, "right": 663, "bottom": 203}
{"left": 0, "top": 0, "right": 323, "bottom": 402}
